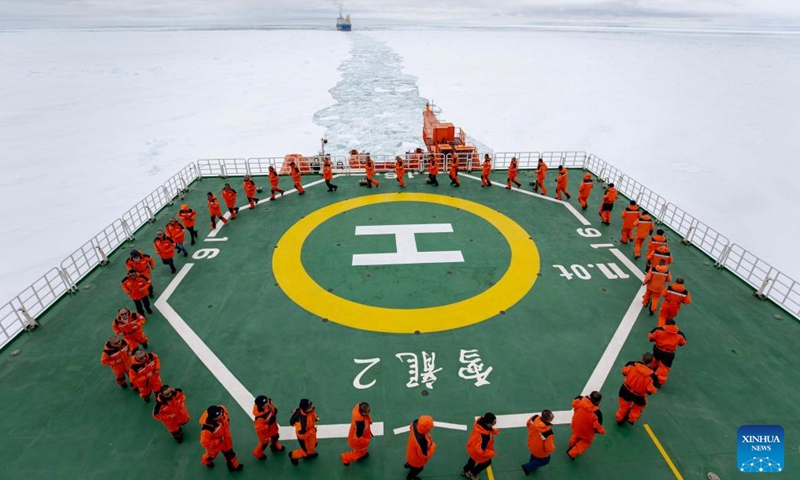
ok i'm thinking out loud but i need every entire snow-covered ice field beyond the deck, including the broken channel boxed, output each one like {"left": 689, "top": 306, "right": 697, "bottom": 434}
{"left": 0, "top": 29, "right": 800, "bottom": 301}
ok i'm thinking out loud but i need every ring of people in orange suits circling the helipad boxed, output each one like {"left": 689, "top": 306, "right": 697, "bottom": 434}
{"left": 100, "top": 161, "right": 691, "bottom": 480}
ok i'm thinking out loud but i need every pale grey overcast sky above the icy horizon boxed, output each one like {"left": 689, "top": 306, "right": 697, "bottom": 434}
{"left": 0, "top": 0, "right": 800, "bottom": 29}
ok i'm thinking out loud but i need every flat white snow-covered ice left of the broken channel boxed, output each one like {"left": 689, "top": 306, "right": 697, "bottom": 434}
{"left": 0, "top": 30, "right": 350, "bottom": 302}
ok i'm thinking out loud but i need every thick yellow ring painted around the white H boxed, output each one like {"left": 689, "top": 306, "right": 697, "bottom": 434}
{"left": 272, "top": 193, "right": 539, "bottom": 333}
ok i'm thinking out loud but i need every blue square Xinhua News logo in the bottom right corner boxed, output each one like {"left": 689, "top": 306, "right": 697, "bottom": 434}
{"left": 736, "top": 425, "right": 784, "bottom": 473}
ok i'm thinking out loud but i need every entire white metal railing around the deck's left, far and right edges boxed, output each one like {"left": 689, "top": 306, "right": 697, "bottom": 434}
{"left": 0, "top": 151, "right": 800, "bottom": 348}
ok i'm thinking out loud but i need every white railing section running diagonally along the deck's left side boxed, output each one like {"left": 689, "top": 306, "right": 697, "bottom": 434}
{"left": 0, "top": 162, "right": 200, "bottom": 348}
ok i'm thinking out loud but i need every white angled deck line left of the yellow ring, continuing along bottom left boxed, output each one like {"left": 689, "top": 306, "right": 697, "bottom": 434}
{"left": 154, "top": 263, "right": 383, "bottom": 440}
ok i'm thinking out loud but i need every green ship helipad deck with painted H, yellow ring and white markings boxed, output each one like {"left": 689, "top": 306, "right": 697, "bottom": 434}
{"left": 0, "top": 170, "right": 800, "bottom": 480}
